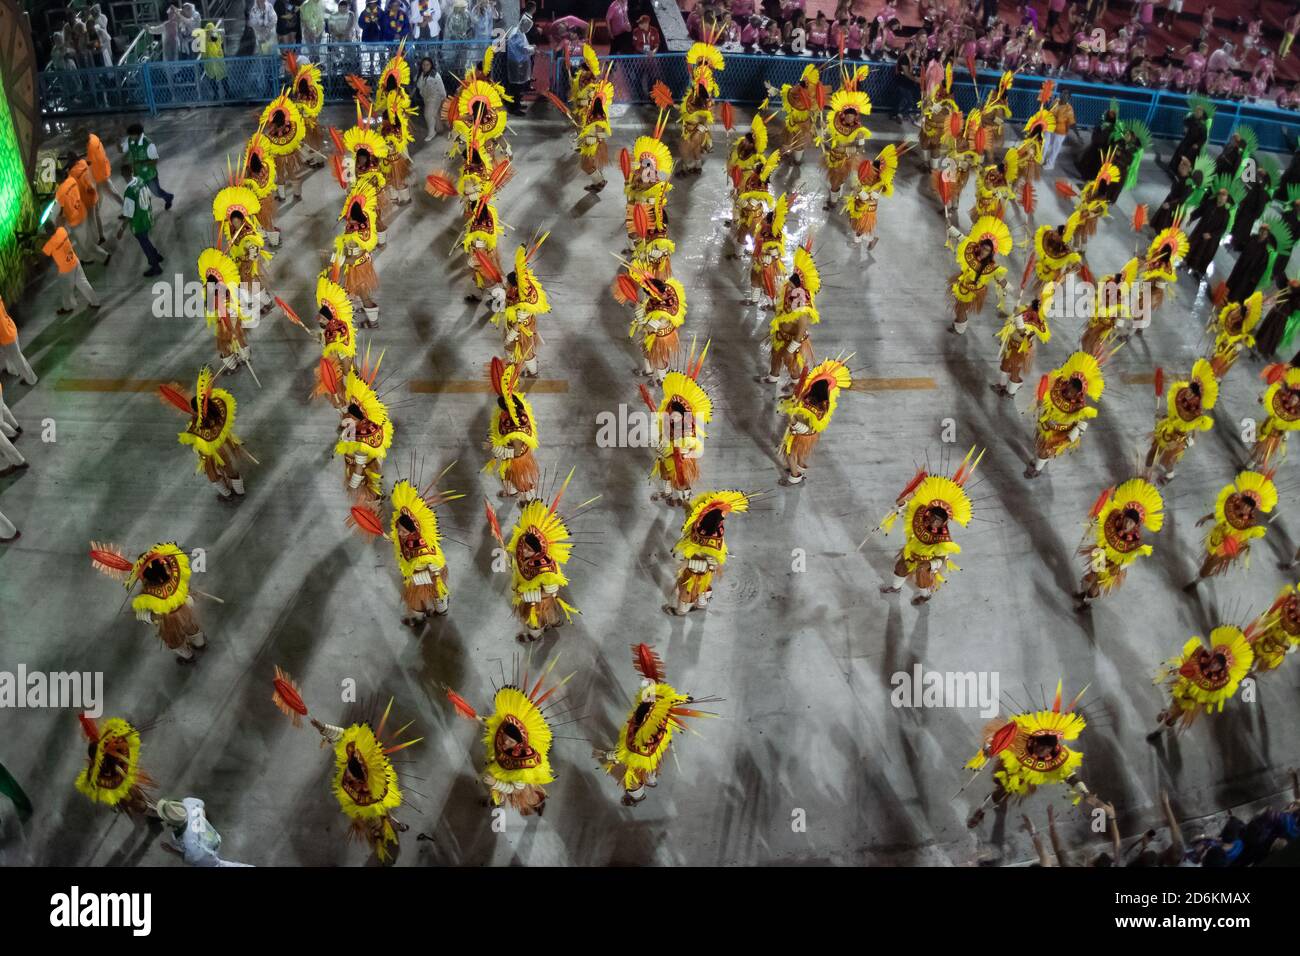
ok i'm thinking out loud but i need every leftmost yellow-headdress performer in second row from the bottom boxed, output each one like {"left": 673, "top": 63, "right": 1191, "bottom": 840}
{"left": 90, "top": 541, "right": 208, "bottom": 663}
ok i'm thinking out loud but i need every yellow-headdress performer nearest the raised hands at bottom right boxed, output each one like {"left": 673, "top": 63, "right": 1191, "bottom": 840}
{"left": 966, "top": 680, "right": 1093, "bottom": 829}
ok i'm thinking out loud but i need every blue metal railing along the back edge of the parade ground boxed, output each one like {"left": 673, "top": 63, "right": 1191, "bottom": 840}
{"left": 40, "top": 40, "right": 1300, "bottom": 152}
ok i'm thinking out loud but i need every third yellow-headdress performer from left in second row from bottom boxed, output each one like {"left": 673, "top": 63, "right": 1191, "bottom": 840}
{"left": 488, "top": 470, "right": 590, "bottom": 644}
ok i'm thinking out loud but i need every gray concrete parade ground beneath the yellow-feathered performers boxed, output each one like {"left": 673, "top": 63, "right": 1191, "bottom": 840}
{"left": 0, "top": 105, "right": 1300, "bottom": 866}
